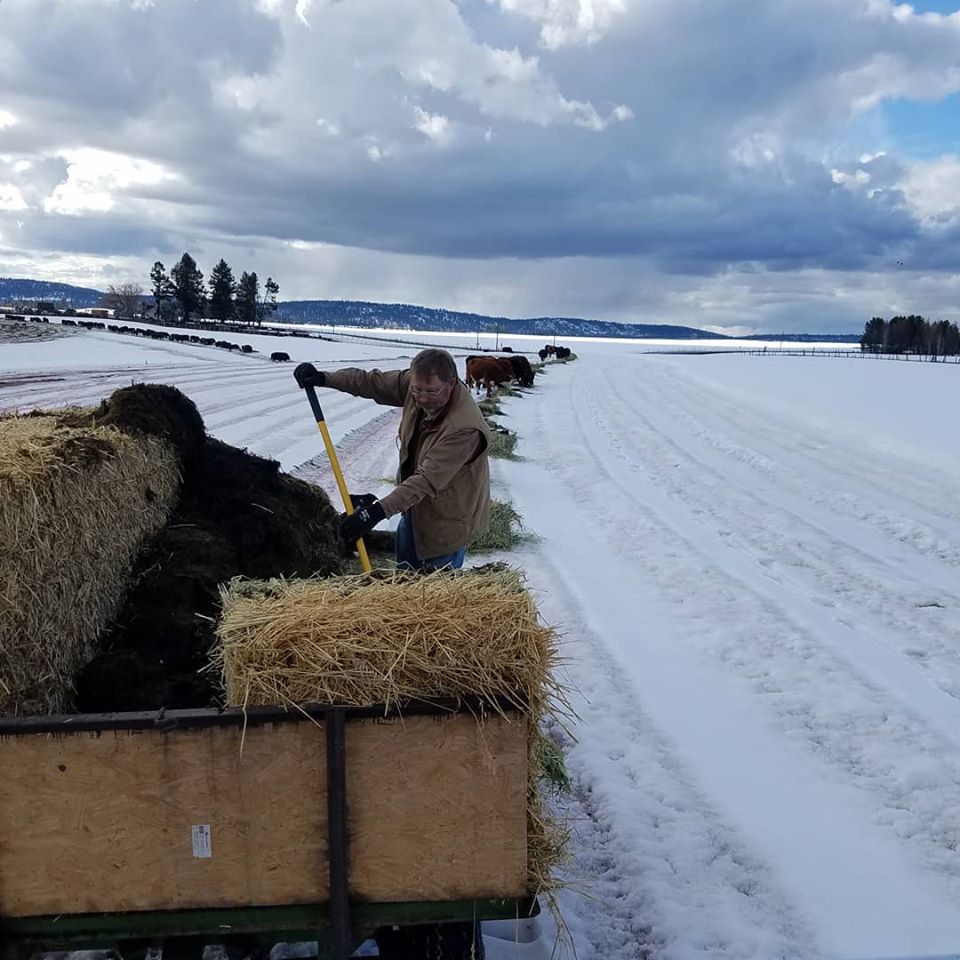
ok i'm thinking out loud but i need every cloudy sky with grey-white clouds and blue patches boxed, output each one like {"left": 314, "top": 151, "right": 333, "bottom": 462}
{"left": 0, "top": 0, "right": 960, "bottom": 332}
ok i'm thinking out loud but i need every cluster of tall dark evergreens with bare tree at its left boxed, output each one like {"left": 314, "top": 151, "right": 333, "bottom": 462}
{"left": 101, "top": 253, "right": 280, "bottom": 325}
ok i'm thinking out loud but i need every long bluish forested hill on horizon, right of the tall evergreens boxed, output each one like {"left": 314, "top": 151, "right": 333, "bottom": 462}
{"left": 277, "top": 300, "right": 727, "bottom": 340}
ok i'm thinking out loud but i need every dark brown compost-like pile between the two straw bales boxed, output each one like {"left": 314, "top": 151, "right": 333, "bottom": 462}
{"left": 69, "top": 384, "right": 343, "bottom": 713}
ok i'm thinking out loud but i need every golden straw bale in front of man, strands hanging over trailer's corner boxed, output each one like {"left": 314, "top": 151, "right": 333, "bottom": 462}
{"left": 214, "top": 567, "right": 569, "bottom": 890}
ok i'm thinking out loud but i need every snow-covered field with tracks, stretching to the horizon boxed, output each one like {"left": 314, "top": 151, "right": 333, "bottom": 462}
{"left": 0, "top": 324, "right": 960, "bottom": 960}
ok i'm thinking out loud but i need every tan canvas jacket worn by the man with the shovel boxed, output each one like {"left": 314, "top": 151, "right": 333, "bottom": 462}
{"left": 326, "top": 367, "right": 490, "bottom": 560}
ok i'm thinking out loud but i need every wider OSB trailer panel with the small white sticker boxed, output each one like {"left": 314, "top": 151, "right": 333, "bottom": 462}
{"left": 0, "top": 723, "right": 327, "bottom": 916}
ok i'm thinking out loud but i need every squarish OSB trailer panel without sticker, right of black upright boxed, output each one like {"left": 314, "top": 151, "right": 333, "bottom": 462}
{"left": 347, "top": 716, "right": 527, "bottom": 901}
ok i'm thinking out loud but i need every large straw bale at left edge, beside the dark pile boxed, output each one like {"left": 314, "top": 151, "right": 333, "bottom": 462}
{"left": 0, "top": 410, "right": 179, "bottom": 714}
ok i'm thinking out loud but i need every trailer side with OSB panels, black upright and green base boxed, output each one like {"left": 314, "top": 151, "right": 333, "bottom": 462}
{"left": 0, "top": 703, "right": 536, "bottom": 960}
